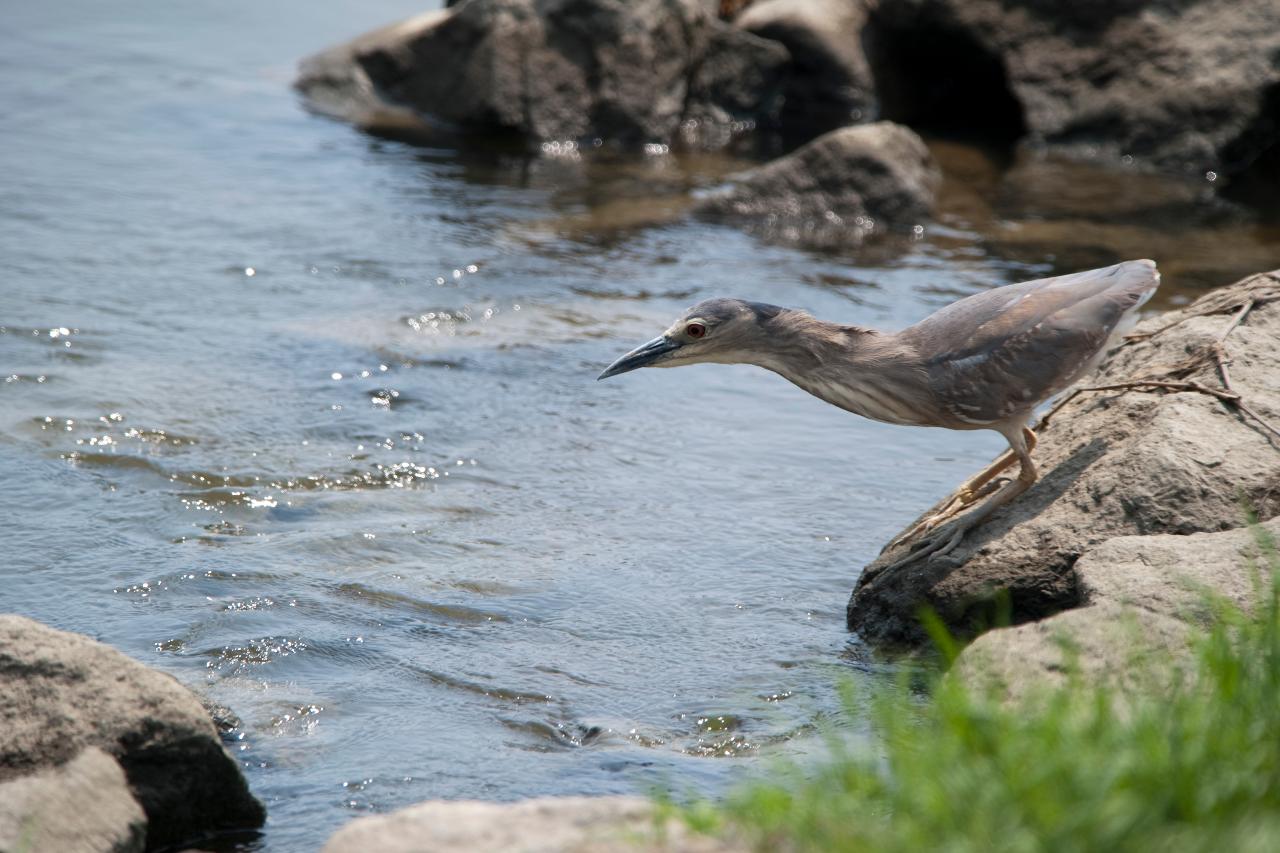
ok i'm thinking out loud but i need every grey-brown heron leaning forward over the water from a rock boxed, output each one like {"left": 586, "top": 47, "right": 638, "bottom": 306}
{"left": 598, "top": 260, "right": 1160, "bottom": 570}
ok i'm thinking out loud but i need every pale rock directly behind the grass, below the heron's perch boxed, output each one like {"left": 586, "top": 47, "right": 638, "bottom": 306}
{"left": 952, "top": 519, "right": 1280, "bottom": 699}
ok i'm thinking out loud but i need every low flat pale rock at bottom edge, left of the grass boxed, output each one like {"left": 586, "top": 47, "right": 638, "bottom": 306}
{"left": 324, "top": 797, "right": 748, "bottom": 853}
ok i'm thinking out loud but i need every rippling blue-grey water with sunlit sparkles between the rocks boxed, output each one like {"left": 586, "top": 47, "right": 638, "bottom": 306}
{"left": 0, "top": 0, "right": 1280, "bottom": 852}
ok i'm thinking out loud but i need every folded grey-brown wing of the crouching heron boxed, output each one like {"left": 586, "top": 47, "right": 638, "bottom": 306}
{"left": 901, "top": 260, "right": 1160, "bottom": 424}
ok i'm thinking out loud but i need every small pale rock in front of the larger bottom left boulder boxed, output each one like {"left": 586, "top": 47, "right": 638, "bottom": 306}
{"left": 0, "top": 747, "right": 147, "bottom": 853}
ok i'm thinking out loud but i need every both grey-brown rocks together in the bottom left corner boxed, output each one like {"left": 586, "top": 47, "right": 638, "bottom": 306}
{"left": 0, "top": 615, "right": 266, "bottom": 853}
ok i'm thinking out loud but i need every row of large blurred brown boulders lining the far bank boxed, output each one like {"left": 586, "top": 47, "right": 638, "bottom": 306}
{"left": 296, "top": 0, "right": 1280, "bottom": 188}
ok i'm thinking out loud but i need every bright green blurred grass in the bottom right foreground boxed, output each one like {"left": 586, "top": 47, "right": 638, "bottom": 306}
{"left": 682, "top": 529, "right": 1280, "bottom": 853}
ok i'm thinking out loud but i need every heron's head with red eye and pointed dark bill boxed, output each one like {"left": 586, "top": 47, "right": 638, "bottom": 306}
{"left": 599, "top": 298, "right": 782, "bottom": 379}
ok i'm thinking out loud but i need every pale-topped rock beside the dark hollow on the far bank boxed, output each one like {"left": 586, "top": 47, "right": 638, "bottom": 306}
{"left": 733, "top": 0, "right": 876, "bottom": 136}
